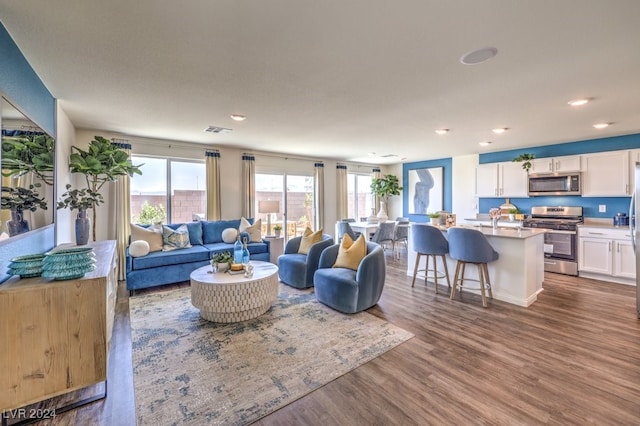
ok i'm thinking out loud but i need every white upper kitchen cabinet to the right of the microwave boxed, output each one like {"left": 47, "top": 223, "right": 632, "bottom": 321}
{"left": 582, "top": 151, "right": 631, "bottom": 197}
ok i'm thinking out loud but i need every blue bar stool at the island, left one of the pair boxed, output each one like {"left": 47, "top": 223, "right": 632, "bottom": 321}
{"left": 411, "top": 223, "right": 451, "bottom": 294}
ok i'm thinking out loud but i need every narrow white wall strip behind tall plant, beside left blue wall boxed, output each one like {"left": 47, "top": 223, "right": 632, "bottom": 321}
{"left": 54, "top": 102, "right": 77, "bottom": 244}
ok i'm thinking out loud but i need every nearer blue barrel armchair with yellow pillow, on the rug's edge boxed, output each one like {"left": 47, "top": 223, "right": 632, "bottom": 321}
{"left": 314, "top": 242, "right": 386, "bottom": 314}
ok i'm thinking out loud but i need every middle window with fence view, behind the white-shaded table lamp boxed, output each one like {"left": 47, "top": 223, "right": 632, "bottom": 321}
{"left": 255, "top": 173, "right": 315, "bottom": 239}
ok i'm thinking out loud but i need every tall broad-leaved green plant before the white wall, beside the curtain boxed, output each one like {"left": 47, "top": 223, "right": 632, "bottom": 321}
{"left": 58, "top": 136, "right": 142, "bottom": 241}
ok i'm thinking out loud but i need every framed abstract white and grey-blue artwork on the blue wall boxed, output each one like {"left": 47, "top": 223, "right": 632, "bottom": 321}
{"left": 407, "top": 167, "right": 444, "bottom": 214}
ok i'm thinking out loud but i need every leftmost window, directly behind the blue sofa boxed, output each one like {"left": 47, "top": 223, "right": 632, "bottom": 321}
{"left": 131, "top": 156, "right": 207, "bottom": 223}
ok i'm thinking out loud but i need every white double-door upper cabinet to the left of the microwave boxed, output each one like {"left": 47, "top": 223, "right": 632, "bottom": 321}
{"left": 476, "top": 161, "right": 528, "bottom": 197}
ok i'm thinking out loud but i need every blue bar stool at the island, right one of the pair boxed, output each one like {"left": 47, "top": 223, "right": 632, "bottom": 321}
{"left": 447, "top": 228, "right": 498, "bottom": 308}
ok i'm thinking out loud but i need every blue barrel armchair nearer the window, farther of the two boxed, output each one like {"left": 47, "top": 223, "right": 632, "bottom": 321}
{"left": 278, "top": 234, "right": 333, "bottom": 288}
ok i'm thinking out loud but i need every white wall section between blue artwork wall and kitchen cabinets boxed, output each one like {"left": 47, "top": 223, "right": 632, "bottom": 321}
{"left": 451, "top": 154, "right": 478, "bottom": 223}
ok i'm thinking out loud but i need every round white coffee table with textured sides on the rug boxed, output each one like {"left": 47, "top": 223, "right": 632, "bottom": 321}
{"left": 190, "top": 260, "right": 279, "bottom": 322}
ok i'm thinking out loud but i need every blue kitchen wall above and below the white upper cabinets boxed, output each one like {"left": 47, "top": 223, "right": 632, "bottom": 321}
{"left": 478, "top": 133, "right": 640, "bottom": 218}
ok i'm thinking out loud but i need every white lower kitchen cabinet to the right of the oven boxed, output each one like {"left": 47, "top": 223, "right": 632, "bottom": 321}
{"left": 578, "top": 227, "right": 636, "bottom": 284}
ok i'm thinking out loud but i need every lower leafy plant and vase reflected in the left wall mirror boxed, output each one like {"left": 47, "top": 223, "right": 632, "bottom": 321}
{"left": 0, "top": 183, "right": 47, "bottom": 237}
